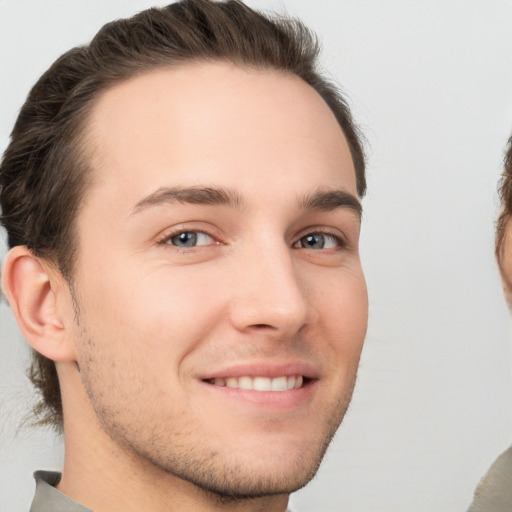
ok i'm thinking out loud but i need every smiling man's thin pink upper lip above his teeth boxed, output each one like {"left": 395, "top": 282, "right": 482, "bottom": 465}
{"left": 200, "top": 361, "right": 319, "bottom": 380}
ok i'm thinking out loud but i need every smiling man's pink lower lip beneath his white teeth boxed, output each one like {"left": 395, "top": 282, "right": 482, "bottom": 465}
{"left": 201, "top": 380, "right": 317, "bottom": 410}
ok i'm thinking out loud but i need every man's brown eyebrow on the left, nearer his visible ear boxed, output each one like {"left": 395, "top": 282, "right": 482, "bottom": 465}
{"left": 132, "top": 186, "right": 244, "bottom": 214}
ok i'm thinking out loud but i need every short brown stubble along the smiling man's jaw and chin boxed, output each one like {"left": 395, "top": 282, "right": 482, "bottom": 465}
{"left": 81, "top": 348, "right": 352, "bottom": 503}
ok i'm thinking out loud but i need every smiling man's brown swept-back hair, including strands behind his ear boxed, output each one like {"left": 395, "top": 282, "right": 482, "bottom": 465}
{"left": 0, "top": 0, "right": 366, "bottom": 430}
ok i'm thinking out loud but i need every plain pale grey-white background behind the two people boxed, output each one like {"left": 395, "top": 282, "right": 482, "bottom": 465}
{"left": 0, "top": 0, "right": 512, "bottom": 512}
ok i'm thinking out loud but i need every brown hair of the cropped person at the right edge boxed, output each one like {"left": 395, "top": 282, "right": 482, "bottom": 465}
{"left": 495, "top": 137, "right": 512, "bottom": 286}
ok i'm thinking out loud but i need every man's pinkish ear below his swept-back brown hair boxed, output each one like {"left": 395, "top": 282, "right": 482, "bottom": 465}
{"left": 2, "top": 246, "right": 75, "bottom": 361}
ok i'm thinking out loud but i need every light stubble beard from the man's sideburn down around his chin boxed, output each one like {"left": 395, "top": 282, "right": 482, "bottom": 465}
{"left": 73, "top": 302, "right": 355, "bottom": 503}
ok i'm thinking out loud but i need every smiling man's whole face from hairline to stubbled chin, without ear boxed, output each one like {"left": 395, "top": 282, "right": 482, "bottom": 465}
{"left": 70, "top": 63, "right": 367, "bottom": 496}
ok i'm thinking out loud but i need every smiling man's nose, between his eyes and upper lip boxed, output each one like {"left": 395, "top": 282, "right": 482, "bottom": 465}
{"left": 230, "top": 241, "right": 313, "bottom": 338}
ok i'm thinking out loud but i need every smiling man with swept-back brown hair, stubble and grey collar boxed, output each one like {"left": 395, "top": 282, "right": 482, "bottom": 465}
{"left": 0, "top": 0, "right": 367, "bottom": 512}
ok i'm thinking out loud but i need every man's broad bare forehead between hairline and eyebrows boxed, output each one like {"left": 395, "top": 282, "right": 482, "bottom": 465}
{"left": 86, "top": 63, "right": 356, "bottom": 207}
